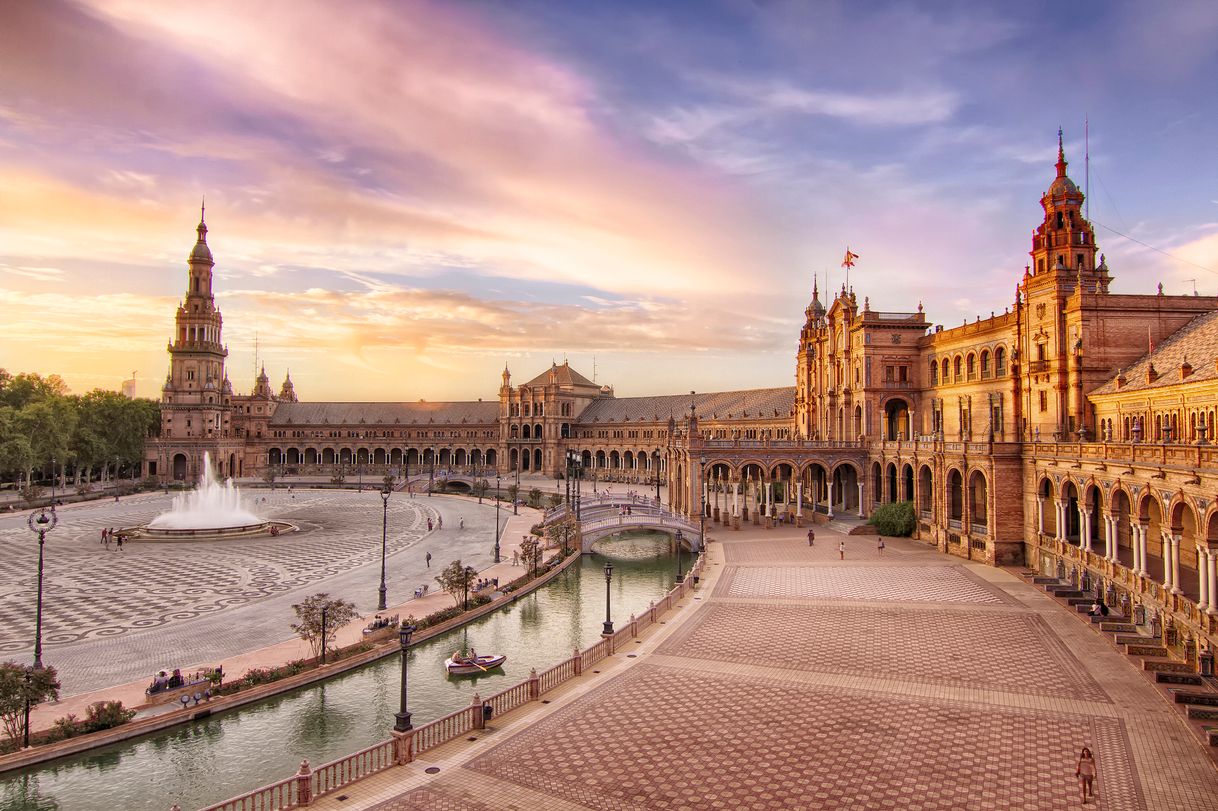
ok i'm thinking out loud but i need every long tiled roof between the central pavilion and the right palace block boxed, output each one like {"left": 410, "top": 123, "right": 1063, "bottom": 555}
{"left": 576, "top": 386, "right": 795, "bottom": 425}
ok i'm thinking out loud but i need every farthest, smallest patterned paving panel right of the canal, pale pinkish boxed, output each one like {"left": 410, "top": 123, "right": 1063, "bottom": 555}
{"left": 715, "top": 565, "right": 1013, "bottom": 605}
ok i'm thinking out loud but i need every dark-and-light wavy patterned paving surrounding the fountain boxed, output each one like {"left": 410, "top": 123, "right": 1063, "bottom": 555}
{"left": 0, "top": 491, "right": 438, "bottom": 654}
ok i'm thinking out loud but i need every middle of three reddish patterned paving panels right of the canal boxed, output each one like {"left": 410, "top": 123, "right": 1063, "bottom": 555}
{"left": 658, "top": 604, "right": 1110, "bottom": 701}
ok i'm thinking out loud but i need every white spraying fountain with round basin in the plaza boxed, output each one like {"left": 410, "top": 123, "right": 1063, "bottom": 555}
{"left": 136, "top": 452, "right": 287, "bottom": 539}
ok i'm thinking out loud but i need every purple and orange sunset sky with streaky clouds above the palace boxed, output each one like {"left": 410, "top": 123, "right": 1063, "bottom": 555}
{"left": 0, "top": 0, "right": 1218, "bottom": 401}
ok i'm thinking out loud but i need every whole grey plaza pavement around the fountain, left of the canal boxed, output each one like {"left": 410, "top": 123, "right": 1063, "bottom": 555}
{"left": 0, "top": 488, "right": 552, "bottom": 729}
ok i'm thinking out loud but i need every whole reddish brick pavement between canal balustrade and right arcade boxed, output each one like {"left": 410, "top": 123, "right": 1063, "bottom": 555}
{"left": 299, "top": 511, "right": 1218, "bottom": 811}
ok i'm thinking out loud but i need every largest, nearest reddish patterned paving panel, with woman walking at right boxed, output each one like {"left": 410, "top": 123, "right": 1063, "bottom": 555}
{"left": 462, "top": 664, "right": 1145, "bottom": 811}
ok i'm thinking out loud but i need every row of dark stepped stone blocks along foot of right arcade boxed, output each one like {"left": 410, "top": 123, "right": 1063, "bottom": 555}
{"left": 1022, "top": 571, "right": 1218, "bottom": 759}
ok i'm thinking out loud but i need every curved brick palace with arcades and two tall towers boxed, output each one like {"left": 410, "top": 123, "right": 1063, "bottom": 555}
{"left": 145, "top": 136, "right": 1218, "bottom": 654}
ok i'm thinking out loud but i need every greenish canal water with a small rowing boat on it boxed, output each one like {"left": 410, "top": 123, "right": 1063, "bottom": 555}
{"left": 0, "top": 533, "right": 674, "bottom": 811}
